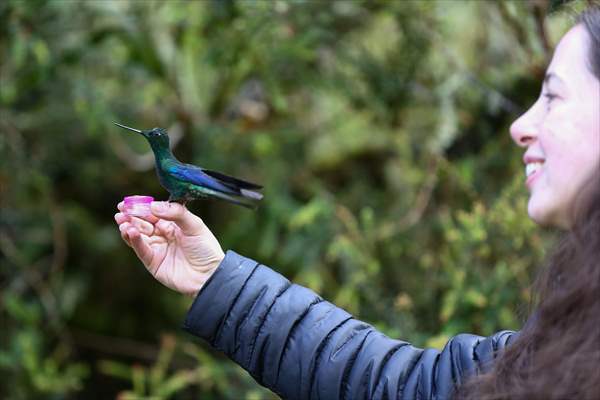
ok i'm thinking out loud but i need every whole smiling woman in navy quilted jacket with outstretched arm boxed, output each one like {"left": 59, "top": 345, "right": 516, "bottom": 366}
{"left": 115, "top": 6, "right": 600, "bottom": 399}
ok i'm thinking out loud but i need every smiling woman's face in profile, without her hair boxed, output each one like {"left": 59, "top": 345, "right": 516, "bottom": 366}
{"left": 510, "top": 25, "right": 600, "bottom": 229}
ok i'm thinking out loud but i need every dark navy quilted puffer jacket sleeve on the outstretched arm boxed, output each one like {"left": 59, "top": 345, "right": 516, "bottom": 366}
{"left": 184, "top": 251, "right": 516, "bottom": 400}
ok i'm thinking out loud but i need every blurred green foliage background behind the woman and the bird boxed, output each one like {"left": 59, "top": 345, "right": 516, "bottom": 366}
{"left": 0, "top": 0, "right": 582, "bottom": 399}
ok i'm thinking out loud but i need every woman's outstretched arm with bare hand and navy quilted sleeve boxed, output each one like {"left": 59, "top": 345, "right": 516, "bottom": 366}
{"left": 115, "top": 202, "right": 514, "bottom": 400}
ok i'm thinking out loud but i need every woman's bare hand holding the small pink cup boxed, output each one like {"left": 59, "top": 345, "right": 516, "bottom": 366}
{"left": 115, "top": 201, "right": 225, "bottom": 297}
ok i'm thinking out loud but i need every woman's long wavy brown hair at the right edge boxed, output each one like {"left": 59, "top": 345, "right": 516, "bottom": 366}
{"left": 454, "top": 4, "right": 600, "bottom": 400}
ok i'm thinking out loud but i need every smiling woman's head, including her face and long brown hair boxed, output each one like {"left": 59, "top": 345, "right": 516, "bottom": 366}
{"left": 457, "top": 6, "right": 600, "bottom": 399}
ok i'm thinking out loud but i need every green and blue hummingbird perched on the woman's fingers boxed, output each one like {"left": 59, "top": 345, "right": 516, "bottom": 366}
{"left": 115, "top": 122, "right": 263, "bottom": 209}
